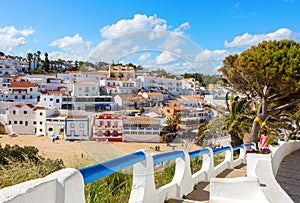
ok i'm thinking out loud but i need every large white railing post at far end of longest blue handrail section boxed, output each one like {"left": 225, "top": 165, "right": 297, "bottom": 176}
{"left": 129, "top": 150, "right": 159, "bottom": 203}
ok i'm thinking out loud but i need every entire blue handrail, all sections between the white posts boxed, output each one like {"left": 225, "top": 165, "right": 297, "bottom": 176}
{"left": 79, "top": 143, "right": 254, "bottom": 184}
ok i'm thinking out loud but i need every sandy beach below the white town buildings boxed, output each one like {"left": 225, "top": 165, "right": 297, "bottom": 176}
{"left": 0, "top": 135, "right": 199, "bottom": 168}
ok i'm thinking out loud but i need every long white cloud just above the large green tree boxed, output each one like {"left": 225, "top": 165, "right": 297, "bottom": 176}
{"left": 224, "top": 28, "right": 293, "bottom": 48}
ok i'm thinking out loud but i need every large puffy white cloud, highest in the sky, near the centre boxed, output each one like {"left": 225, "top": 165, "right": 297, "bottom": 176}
{"left": 100, "top": 14, "right": 167, "bottom": 39}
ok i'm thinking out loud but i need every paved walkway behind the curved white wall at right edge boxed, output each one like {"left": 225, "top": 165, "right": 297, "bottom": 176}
{"left": 276, "top": 150, "right": 300, "bottom": 203}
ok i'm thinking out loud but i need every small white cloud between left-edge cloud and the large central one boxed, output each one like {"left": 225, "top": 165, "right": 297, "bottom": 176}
{"left": 49, "top": 34, "right": 91, "bottom": 55}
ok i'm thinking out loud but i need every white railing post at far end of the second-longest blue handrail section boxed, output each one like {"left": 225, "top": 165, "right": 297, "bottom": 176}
{"left": 172, "top": 150, "right": 194, "bottom": 198}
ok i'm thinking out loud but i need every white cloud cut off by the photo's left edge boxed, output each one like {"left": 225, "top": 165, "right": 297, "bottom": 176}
{"left": 0, "top": 26, "right": 35, "bottom": 53}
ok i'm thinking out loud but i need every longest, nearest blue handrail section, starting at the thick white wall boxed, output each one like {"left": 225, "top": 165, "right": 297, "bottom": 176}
{"left": 79, "top": 151, "right": 145, "bottom": 184}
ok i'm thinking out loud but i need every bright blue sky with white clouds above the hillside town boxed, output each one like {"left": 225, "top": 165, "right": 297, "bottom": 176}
{"left": 0, "top": 0, "right": 300, "bottom": 73}
